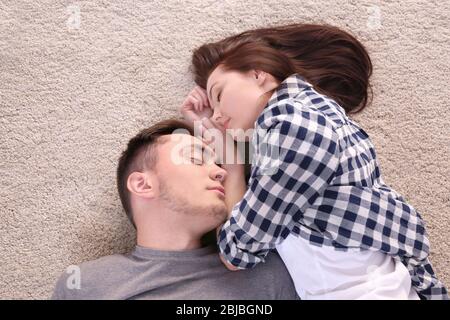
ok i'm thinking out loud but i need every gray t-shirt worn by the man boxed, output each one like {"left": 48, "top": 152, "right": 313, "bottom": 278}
{"left": 52, "top": 245, "right": 298, "bottom": 300}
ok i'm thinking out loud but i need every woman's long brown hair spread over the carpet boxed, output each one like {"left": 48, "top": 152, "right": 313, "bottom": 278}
{"left": 190, "top": 24, "right": 372, "bottom": 113}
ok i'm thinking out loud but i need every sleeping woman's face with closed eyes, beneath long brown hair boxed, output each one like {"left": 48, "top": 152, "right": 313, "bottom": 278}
{"left": 206, "top": 66, "right": 278, "bottom": 139}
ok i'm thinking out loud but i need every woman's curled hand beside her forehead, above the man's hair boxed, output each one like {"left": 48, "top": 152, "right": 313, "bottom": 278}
{"left": 179, "top": 86, "right": 213, "bottom": 123}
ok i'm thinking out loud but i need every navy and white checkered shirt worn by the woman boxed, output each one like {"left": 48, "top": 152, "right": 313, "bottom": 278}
{"left": 218, "top": 74, "right": 448, "bottom": 299}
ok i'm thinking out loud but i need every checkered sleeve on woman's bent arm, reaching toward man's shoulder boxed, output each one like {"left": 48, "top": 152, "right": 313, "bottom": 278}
{"left": 218, "top": 105, "right": 339, "bottom": 269}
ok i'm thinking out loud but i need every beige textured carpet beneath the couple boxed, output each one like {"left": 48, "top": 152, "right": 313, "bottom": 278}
{"left": 0, "top": 0, "right": 450, "bottom": 299}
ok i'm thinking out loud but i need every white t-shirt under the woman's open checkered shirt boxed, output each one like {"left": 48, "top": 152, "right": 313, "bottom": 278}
{"left": 277, "top": 234, "right": 419, "bottom": 300}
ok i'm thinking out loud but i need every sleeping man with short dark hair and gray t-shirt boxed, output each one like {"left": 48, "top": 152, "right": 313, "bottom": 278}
{"left": 52, "top": 120, "right": 297, "bottom": 299}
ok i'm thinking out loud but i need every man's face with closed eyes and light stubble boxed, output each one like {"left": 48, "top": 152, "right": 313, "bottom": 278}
{"left": 155, "top": 134, "right": 228, "bottom": 233}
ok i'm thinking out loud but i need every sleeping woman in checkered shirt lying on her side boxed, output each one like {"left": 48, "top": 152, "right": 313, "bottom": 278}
{"left": 181, "top": 24, "right": 448, "bottom": 299}
